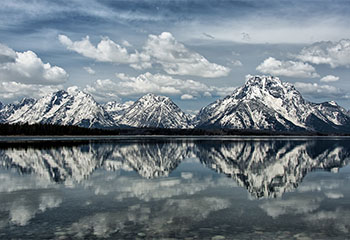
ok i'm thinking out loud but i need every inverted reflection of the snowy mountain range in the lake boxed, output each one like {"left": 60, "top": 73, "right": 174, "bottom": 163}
{"left": 0, "top": 140, "right": 350, "bottom": 198}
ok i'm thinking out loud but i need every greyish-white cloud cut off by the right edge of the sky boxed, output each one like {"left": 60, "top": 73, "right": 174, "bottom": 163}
{"left": 296, "top": 39, "right": 350, "bottom": 68}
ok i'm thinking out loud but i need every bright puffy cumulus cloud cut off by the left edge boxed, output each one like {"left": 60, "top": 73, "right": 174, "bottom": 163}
{"left": 0, "top": 44, "right": 68, "bottom": 85}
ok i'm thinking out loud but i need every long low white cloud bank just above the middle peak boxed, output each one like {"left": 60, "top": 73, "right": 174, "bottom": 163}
{"left": 85, "top": 72, "right": 234, "bottom": 101}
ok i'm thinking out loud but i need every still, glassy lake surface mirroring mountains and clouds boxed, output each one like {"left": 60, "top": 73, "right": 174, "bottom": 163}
{"left": 0, "top": 136, "right": 350, "bottom": 239}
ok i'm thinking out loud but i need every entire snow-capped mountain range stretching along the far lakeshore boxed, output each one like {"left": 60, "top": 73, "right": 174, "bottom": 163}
{"left": 0, "top": 76, "right": 350, "bottom": 133}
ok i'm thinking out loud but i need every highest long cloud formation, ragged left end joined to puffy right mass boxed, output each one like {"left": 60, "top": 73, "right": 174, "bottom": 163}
{"left": 58, "top": 32, "right": 230, "bottom": 78}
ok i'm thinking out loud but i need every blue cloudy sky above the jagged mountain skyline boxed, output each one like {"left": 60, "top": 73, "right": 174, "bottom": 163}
{"left": 0, "top": 0, "right": 350, "bottom": 113}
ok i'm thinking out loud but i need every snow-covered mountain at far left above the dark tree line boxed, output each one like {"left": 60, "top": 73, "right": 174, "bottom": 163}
{"left": 1, "top": 87, "right": 115, "bottom": 128}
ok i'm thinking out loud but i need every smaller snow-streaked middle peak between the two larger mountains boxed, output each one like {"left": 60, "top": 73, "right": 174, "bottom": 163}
{"left": 119, "top": 94, "right": 191, "bottom": 128}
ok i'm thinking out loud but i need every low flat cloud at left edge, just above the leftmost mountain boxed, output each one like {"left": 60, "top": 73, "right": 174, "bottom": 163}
{"left": 0, "top": 82, "right": 63, "bottom": 102}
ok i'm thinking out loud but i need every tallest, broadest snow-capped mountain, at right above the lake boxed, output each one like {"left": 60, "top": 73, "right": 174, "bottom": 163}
{"left": 195, "top": 76, "right": 350, "bottom": 132}
